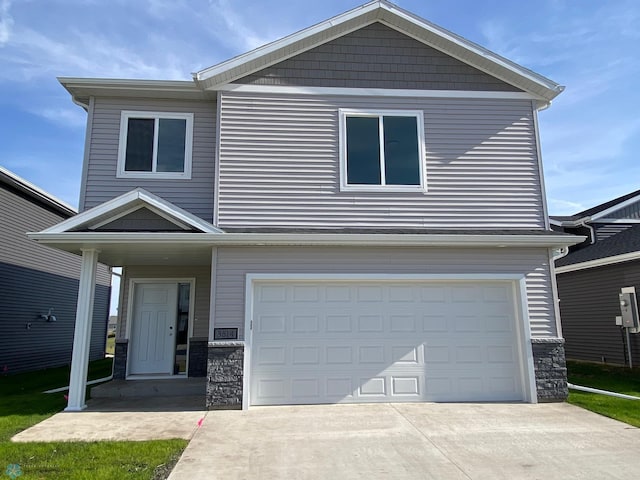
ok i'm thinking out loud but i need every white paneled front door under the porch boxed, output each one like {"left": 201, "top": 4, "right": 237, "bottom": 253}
{"left": 129, "top": 283, "right": 178, "bottom": 375}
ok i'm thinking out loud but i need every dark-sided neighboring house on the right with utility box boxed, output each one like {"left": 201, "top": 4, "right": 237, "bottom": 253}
{"left": 551, "top": 190, "right": 640, "bottom": 366}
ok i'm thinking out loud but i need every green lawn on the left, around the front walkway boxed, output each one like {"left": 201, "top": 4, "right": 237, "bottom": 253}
{"left": 0, "top": 360, "right": 188, "bottom": 480}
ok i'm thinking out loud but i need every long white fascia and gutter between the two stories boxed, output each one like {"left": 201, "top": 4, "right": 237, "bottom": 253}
{"left": 28, "top": 231, "right": 586, "bottom": 248}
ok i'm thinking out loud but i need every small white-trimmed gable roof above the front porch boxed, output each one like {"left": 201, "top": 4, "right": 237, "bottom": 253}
{"left": 41, "top": 188, "right": 222, "bottom": 233}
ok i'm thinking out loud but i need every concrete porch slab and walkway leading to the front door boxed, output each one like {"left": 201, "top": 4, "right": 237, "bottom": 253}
{"left": 11, "top": 395, "right": 207, "bottom": 442}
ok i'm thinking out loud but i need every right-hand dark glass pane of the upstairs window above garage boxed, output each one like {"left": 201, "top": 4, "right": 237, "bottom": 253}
{"left": 384, "top": 117, "right": 420, "bottom": 185}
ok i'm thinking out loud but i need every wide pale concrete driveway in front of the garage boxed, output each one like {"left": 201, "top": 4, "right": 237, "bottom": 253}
{"left": 169, "top": 403, "right": 640, "bottom": 480}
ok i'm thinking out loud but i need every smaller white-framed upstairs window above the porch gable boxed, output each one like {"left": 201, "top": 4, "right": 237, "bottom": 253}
{"left": 118, "top": 111, "right": 193, "bottom": 179}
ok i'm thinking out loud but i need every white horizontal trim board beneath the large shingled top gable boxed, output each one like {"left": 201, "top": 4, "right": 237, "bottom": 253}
{"left": 218, "top": 83, "right": 543, "bottom": 100}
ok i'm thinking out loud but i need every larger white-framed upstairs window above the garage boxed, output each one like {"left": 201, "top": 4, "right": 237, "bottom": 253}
{"left": 340, "top": 109, "right": 426, "bottom": 192}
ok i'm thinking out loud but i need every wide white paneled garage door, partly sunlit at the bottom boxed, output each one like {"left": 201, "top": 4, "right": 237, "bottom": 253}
{"left": 250, "top": 281, "right": 524, "bottom": 405}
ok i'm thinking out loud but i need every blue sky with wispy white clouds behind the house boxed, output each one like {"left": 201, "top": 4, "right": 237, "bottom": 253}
{"left": 0, "top": 0, "right": 640, "bottom": 215}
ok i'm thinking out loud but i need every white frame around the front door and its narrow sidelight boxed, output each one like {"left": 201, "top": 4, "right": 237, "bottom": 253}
{"left": 125, "top": 277, "right": 196, "bottom": 380}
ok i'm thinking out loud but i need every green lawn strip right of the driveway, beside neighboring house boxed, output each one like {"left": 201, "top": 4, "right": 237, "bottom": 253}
{"left": 567, "top": 362, "right": 640, "bottom": 427}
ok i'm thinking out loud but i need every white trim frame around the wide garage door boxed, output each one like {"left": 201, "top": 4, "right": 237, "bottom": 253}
{"left": 242, "top": 273, "right": 538, "bottom": 410}
